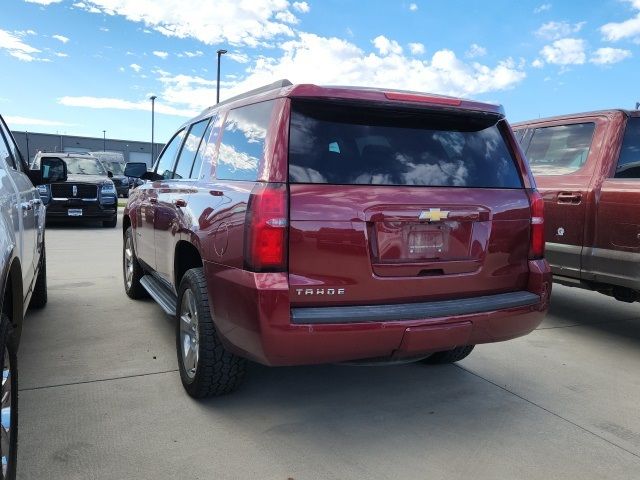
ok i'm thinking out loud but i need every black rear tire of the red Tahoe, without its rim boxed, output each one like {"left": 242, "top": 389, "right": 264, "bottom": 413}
{"left": 176, "top": 268, "right": 247, "bottom": 398}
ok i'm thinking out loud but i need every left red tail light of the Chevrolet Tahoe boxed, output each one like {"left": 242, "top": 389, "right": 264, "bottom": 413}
{"left": 244, "top": 183, "right": 289, "bottom": 272}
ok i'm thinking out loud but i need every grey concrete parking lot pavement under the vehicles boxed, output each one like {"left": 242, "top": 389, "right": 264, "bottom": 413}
{"left": 13, "top": 215, "right": 640, "bottom": 480}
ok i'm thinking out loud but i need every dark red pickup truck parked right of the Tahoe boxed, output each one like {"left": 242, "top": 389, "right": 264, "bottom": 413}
{"left": 514, "top": 110, "right": 640, "bottom": 302}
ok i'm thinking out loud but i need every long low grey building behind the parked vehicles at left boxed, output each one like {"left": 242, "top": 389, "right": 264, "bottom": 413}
{"left": 12, "top": 130, "right": 164, "bottom": 166}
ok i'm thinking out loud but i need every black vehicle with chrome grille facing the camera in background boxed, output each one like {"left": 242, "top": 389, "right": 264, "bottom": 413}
{"left": 31, "top": 152, "right": 118, "bottom": 228}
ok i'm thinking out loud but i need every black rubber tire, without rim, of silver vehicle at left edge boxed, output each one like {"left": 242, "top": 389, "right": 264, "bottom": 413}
{"left": 0, "top": 314, "right": 18, "bottom": 480}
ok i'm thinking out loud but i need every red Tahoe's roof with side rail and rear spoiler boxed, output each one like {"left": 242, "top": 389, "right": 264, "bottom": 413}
{"left": 187, "top": 80, "right": 504, "bottom": 124}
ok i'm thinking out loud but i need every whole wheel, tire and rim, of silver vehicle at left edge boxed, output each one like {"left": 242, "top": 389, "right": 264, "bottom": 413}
{"left": 0, "top": 314, "right": 18, "bottom": 480}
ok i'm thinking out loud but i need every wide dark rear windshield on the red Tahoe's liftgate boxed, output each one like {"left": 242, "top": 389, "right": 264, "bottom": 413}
{"left": 289, "top": 100, "right": 522, "bottom": 188}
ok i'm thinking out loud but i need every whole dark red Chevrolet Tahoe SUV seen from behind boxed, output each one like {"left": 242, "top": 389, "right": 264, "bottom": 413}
{"left": 123, "top": 81, "right": 551, "bottom": 397}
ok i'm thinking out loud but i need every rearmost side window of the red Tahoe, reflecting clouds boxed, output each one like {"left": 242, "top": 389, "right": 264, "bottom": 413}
{"left": 216, "top": 101, "right": 273, "bottom": 180}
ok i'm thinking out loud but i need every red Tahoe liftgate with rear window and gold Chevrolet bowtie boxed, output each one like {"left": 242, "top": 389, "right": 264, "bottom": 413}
{"left": 289, "top": 98, "right": 531, "bottom": 307}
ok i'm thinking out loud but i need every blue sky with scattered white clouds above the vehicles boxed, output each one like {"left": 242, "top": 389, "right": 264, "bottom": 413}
{"left": 0, "top": 0, "right": 640, "bottom": 141}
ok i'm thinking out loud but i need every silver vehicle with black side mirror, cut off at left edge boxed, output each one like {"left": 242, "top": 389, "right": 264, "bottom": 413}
{"left": 0, "top": 111, "right": 66, "bottom": 479}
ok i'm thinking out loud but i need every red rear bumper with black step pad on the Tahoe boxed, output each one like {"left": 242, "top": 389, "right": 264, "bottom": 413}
{"left": 205, "top": 260, "right": 551, "bottom": 365}
